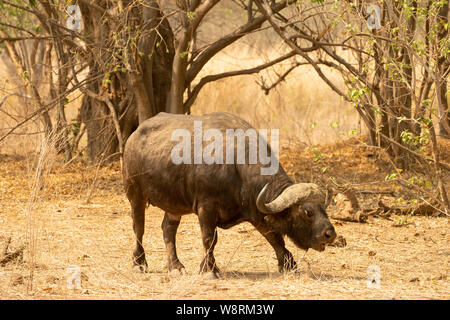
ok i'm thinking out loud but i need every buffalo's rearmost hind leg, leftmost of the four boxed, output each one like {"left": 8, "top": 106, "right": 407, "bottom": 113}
{"left": 127, "top": 185, "right": 147, "bottom": 272}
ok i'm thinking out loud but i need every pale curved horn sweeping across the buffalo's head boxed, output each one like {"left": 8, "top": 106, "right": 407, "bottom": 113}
{"left": 256, "top": 183, "right": 325, "bottom": 214}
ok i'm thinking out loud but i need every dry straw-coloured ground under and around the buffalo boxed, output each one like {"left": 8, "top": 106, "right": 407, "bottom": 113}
{"left": 0, "top": 144, "right": 450, "bottom": 299}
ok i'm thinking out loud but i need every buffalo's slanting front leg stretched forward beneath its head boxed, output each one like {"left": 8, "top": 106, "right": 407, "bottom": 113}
{"left": 252, "top": 222, "right": 297, "bottom": 273}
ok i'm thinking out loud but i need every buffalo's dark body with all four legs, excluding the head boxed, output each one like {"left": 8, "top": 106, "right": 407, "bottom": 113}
{"left": 123, "top": 113, "right": 334, "bottom": 272}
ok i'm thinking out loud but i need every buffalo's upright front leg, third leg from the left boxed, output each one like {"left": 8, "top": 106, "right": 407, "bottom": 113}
{"left": 198, "top": 207, "right": 220, "bottom": 278}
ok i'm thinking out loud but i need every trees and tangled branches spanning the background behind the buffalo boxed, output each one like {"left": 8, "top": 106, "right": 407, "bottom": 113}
{"left": 0, "top": 0, "right": 450, "bottom": 212}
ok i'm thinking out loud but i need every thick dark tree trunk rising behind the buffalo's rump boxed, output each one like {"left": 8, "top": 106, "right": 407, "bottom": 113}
{"left": 80, "top": 1, "right": 174, "bottom": 161}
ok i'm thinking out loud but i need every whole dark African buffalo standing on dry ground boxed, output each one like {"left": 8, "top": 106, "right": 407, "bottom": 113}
{"left": 123, "top": 113, "right": 336, "bottom": 276}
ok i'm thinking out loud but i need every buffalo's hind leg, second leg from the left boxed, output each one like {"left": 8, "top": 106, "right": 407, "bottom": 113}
{"left": 161, "top": 212, "right": 184, "bottom": 272}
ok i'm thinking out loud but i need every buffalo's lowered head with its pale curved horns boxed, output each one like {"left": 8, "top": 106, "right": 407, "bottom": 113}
{"left": 256, "top": 183, "right": 336, "bottom": 251}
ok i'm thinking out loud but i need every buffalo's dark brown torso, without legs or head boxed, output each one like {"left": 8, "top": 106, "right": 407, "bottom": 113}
{"left": 124, "top": 113, "right": 292, "bottom": 228}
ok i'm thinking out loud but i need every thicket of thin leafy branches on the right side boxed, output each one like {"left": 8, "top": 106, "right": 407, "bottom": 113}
{"left": 255, "top": 0, "right": 450, "bottom": 212}
